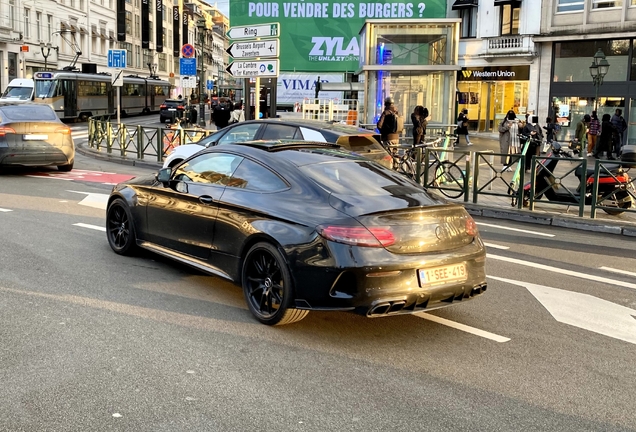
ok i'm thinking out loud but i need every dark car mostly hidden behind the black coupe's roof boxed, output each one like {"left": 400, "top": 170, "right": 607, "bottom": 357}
{"left": 163, "top": 119, "right": 393, "bottom": 168}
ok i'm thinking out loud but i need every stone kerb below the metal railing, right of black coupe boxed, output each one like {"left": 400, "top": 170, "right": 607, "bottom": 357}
{"left": 464, "top": 203, "right": 636, "bottom": 237}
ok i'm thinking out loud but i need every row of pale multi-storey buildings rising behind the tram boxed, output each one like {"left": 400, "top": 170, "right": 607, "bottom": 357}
{"left": 0, "top": 0, "right": 231, "bottom": 95}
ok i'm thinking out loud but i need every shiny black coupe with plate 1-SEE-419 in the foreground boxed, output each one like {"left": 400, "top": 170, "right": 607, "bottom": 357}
{"left": 106, "top": 141, "right": 486, "bottom": 325}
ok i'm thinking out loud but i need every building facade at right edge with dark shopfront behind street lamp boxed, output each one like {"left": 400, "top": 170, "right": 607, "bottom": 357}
{"left": 535, "top": 0, "right": 636, "bottom": 144}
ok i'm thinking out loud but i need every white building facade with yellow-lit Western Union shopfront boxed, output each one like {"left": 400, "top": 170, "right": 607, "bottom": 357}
{"left": 448, "top": 0, "right": 544, "bottom": 131}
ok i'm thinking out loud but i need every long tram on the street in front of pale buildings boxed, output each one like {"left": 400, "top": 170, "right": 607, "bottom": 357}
{"left": 33, "top": 71, "right": 170, "bottom": 121}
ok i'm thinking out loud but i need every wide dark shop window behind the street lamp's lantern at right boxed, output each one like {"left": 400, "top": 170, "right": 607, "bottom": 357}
{"left": 553, "top": 39, "right": 630, "bottom": 82}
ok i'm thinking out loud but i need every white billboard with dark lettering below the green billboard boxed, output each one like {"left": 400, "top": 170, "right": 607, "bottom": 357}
{"left": 276, "top": 72, "right": 344, "bottom": 105}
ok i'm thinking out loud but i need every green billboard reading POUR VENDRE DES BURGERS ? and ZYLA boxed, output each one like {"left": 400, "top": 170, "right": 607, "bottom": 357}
{"left": 230, "top": 0, "right": 446, "bottom": 72}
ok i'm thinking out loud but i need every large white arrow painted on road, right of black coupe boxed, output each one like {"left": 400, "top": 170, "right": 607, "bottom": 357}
{"left": 488, "top": 276, "right": 636, "bottom": 344}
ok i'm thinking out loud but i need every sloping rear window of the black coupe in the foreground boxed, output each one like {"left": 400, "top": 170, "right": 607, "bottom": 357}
{"left": 299, "top": 160, "right": 424, "bottom": 196}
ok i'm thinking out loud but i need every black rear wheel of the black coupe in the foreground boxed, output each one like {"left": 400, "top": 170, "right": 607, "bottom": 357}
{"left": 241, "top": 242, "right": 309, "bottom": 325}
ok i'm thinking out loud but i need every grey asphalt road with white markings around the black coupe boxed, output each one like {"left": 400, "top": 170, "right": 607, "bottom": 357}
{"left": 0, "top": 121, "right": 636, "bottom": 432}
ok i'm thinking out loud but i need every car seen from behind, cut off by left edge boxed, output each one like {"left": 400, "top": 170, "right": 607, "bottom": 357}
{"left": 0, "top": 102, "right": 75, "bottom": 171}
